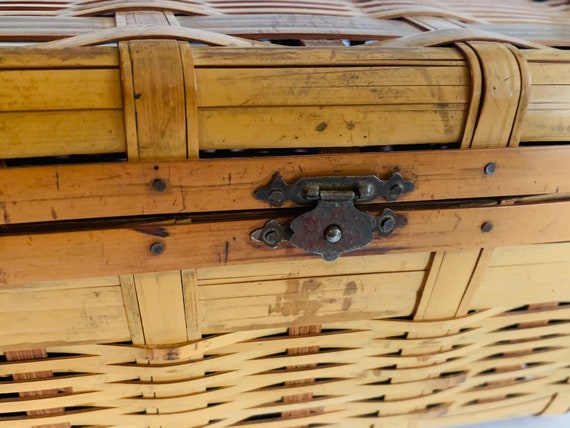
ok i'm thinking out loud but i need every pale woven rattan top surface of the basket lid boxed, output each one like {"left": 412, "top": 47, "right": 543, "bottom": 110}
{"left": 0, "top": 0, "right": 570, "bottom": 46}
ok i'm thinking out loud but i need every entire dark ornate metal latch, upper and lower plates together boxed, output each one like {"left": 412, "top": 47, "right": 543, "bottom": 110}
{"left": 251, "top": 172, "right": 415, "bottom": 261}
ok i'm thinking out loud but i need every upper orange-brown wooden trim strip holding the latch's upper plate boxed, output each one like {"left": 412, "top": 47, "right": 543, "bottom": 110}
{"left": 0, "top": 146, "right": 570, "bottom": 224}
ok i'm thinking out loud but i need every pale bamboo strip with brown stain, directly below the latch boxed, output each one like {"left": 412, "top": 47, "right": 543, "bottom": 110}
{"left": 198, "top": 272, "right": 424, "bottom": 332}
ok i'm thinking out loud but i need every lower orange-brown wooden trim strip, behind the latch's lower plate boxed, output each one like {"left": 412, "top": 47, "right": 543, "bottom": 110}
{"left": 0, "top": 202, "right": 570, "bottom": 285}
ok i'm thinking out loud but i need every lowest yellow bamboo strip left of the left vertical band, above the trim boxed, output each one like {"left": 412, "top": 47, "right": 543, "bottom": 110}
{"left": 0, "top": 109, "right": 126, "bottom": 159}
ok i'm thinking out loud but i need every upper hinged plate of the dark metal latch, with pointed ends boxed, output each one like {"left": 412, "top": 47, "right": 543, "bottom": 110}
{"left": 254, "top": 172, "right": 415, "bottom": 207}
